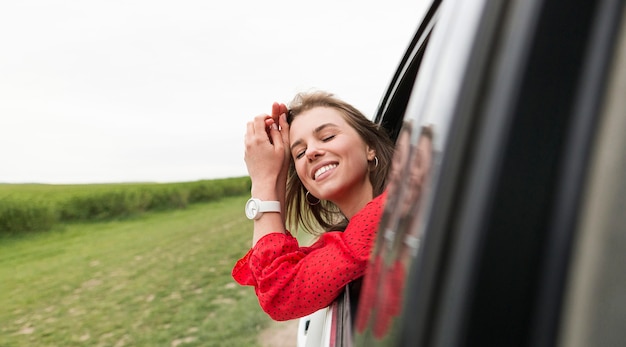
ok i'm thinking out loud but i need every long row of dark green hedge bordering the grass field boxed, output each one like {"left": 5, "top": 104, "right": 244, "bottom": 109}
{"left": 0, "top": 177, "right": 250, "bottom": 234}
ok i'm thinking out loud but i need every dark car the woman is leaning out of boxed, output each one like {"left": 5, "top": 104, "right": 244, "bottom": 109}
{"left": 299, "top": 0, "right": 626, "bottom": 347}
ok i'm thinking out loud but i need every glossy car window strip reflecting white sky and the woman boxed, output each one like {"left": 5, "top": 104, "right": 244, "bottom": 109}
{"left": 354, "top": 2, "right": 492, "bottom": 346}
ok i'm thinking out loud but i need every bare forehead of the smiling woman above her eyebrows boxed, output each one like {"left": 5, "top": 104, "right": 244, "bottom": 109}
{"left": 289, "top": 106, "right": 350, "bottom": 140}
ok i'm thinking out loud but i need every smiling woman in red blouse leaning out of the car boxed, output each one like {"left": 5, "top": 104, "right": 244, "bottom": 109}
{"left": 233, "top": 92, "right": 393, "bottom": 320}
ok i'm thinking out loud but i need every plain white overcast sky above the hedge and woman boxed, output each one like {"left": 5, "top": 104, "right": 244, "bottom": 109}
{"left": 0, "top": 0, "right": 426, "bottom": 183}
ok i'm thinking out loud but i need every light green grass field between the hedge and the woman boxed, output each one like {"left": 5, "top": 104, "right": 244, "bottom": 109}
{"left": 0, "top": 196, "right": 270, "bottom": 347}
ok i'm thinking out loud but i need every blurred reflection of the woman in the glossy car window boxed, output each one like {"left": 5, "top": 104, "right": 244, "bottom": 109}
{"left": 356, "top": 120, "right": 433, "bottom": 345}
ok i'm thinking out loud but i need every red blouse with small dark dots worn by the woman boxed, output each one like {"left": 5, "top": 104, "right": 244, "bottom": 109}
{"left": 232, "top": 193, "right": 387, "bottom": 321}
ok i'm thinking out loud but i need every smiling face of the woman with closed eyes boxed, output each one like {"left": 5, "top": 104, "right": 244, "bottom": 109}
{"left": 289, "top": 107, "right": 375, "bottom": 207}
